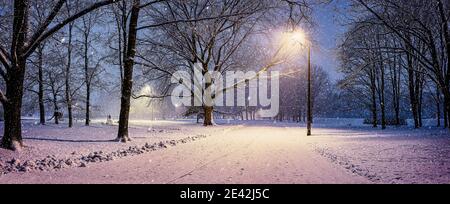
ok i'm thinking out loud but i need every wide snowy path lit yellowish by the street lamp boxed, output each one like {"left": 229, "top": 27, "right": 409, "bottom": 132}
{"left": 0, "top": 126, "right": 369, "bottom": 184}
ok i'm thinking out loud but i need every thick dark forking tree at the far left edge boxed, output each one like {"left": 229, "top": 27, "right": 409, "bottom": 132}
{"left": 0, "top": 0, "right": 115, "bottom": 150}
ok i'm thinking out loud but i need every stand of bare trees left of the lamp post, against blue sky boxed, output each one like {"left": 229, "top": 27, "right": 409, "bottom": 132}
{"left": 0, "top": 0, "right": 309, "bottom": 150}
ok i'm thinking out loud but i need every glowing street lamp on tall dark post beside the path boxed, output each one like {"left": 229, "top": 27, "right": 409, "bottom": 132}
{"left": 287, "top": 30, "right": 312, "bottom": 136}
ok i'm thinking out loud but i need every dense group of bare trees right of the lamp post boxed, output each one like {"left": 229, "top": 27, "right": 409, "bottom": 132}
{"left": 339, "top": 0, "right": 450, "bottom": 128}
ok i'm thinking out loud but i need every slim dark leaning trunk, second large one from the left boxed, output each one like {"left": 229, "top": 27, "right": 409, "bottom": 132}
{"left": 117, "top": 0, "right": 142, "bottom": 142}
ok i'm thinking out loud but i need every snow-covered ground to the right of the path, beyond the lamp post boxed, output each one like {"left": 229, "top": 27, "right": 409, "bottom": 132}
{"left": 302, "top": 128, "right": 450, "bottom": 183}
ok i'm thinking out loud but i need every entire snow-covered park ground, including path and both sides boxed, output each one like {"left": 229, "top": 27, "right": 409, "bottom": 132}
{"left": 0, "top": 118, "right": 450, "bottom": 184}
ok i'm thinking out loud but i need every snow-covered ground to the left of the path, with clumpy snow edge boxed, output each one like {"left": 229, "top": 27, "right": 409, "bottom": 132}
{"left": 0, "top": 119, "right": 232, "bottom": 175}
